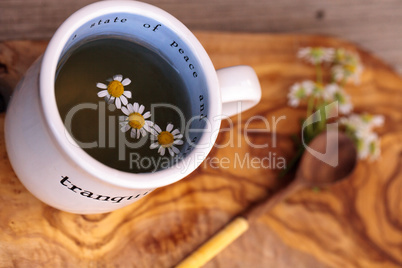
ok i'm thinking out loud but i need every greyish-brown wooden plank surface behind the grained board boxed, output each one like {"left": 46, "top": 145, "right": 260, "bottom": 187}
{"left": 0, "top": 0, "right": 402, "bottom": 73}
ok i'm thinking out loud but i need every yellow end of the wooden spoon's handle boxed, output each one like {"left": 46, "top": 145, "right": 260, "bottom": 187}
{"left": 176, "top": 217, "right": 248, "bottom": 268}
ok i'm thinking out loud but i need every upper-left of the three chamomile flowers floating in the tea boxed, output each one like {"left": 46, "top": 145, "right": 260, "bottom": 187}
{"left": 96, "top": 74, "right": 131, "bottom": 109}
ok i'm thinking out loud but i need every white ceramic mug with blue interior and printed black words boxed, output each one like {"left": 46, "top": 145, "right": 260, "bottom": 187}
{"left": 5, "top": 1, "right": 261, "bottom": 214}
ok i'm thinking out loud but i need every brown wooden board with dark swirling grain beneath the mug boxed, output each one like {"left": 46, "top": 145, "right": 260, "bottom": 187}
{"left": 0, "top": 32, "right": 402, "bottom": 268}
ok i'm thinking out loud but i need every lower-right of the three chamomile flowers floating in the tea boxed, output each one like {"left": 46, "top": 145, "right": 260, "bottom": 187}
{"left": 149, "top": 124, "right": 183, "bottom": 156}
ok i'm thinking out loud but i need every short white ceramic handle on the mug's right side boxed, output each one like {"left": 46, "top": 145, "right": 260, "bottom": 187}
{"left": 216, "top": 65, "right": 261, "bottom": 116}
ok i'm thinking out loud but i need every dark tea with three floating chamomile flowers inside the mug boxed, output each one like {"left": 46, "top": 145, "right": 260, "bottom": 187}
{"left": 55, "top": 37, "right": 191, "bottom": 173}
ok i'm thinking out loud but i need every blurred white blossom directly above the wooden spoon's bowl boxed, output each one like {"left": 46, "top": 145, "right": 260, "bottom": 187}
{"left": 323, "top": 83, "right": 353, "bottom": 114}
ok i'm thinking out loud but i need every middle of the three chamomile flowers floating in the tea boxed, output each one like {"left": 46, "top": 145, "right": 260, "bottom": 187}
{"left": 120, "top": 102, "right": 153, "bottom": 139}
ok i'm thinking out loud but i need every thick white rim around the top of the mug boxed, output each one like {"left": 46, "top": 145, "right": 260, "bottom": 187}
{"left": 39, "top": 1, "right": 222, "bottom": 189}
